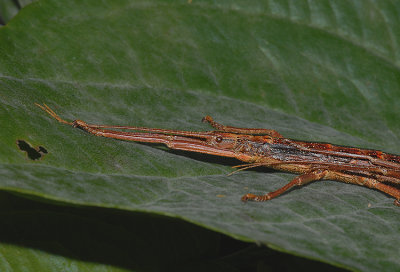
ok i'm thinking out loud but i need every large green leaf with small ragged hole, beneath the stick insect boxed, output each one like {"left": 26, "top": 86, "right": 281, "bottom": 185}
{"left": 0, "top": 0, "right": 400, "bottom": 270}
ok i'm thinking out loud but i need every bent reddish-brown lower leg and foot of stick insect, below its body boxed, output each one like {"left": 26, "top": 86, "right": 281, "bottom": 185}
{"left": 242, "top": 169, "right": 329, "bottom": 201}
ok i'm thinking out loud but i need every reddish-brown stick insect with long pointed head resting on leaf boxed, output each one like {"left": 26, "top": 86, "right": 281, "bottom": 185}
{"left": 36, "top": 104, "right": 400, "bottom": 206}
